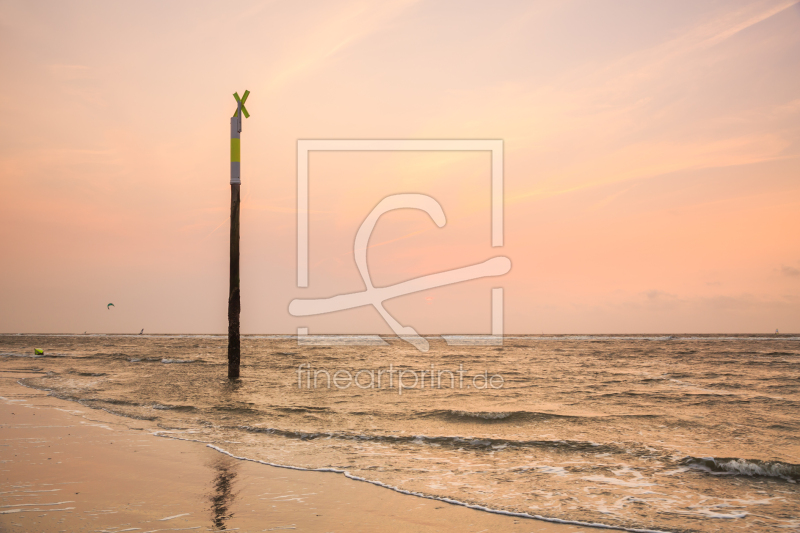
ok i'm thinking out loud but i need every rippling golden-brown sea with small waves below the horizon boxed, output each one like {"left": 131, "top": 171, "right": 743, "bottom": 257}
{"left": 0, "top": 334, "right": 800, "bottom": 532}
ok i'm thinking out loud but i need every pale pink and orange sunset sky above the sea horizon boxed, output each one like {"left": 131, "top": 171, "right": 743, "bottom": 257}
{"left": 0, "top": 0, "right": 800, "bottom": 334}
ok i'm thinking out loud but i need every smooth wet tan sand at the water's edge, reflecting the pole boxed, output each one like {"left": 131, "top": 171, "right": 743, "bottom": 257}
{"left": 0, "top": 372, "right": 601, "bottom": 533}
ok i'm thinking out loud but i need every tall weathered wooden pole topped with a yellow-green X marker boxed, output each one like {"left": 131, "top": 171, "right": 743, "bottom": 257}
{"left": 228, "top": 91, "right": 250, "bottom": 379}
